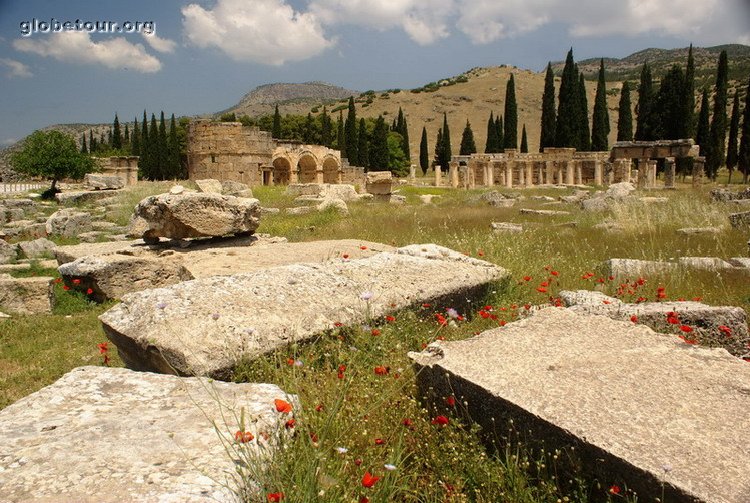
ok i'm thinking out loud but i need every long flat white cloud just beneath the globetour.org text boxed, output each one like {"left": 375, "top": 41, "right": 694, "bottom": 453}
{"left": 13, "top": 31, "right": 161, "bottom": 73}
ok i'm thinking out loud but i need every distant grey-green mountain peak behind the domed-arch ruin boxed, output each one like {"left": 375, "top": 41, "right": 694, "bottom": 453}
{"left": 216, "top": 82, "right": 358, "bottom": 117}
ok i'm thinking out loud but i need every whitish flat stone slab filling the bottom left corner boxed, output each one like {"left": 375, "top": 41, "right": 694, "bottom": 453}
{"left": 0, "top": 367, "right": 298, "bottom": 503}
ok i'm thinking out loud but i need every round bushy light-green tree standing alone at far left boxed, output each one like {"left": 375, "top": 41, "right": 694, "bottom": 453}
{"left": 10, "top": 130, "right": 96, "bottom": 199}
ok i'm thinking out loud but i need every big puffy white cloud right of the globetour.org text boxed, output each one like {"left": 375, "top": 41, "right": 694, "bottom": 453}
{"left": 182, "top": 0, "right": 335, "bottom": 65}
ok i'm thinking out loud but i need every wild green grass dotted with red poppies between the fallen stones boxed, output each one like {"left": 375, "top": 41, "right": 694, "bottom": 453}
{"left": 0, "top": 184, "right": 750, "bottom": 502}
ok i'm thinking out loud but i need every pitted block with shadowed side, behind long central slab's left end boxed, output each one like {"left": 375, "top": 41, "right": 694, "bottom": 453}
{"left": 58, "top": 253, "right": 193, "bottom": 302}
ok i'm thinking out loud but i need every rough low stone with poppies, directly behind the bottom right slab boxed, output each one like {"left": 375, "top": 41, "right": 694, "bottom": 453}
{"left": 560, "top": 290, "right": 750, "bottom": 357}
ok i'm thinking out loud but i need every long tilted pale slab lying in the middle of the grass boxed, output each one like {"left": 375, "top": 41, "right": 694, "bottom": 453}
{"left": 99, "top": 245, "right": 508, "bottom": 378}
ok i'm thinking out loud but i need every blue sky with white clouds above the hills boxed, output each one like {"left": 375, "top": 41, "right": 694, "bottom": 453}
{"left": 0, "top": 0, "right": 750, "bottom": 147}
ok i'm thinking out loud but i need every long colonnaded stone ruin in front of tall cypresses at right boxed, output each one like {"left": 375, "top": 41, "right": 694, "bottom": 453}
{"left": 435, "top": 140, "right": 705, "bottom": 189}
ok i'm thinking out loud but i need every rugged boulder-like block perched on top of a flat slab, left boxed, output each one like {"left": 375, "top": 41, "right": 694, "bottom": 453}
{"left": 135, "top": 192, "right": 260, "bottom": 239}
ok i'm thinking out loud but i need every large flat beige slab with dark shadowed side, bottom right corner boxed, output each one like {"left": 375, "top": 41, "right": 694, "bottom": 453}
{"left": 409, "top": 308, "right": 750, "bottom": 503}
